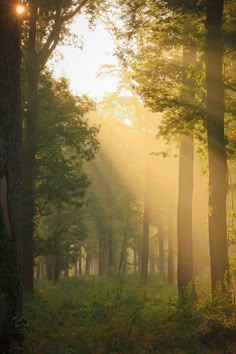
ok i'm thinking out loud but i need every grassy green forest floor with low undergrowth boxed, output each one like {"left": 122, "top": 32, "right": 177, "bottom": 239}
{"left": 24, "top": 278, "right": 236, "bottom": 354}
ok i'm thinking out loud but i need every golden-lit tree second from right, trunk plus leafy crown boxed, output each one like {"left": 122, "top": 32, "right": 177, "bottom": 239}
{"left": 110, "top": 1, "right": 203, "bottom": 296}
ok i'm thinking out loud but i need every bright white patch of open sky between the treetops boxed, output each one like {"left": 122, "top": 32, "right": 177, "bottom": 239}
{"left": 49, "top": 15, "right": 118, "bottom": 99}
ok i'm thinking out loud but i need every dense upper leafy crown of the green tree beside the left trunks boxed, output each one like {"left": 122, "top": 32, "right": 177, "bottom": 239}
{"left": 36, "top": 73, "right": 98, "bottom": 215}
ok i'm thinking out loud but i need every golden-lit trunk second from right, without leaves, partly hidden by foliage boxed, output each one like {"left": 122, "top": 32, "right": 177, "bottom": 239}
{"left": 177, "top": 18, "right": 196, "bottom": 298}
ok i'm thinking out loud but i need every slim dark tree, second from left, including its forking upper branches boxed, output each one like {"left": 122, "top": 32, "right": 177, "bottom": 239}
{"left": 23, "top": 0, "right": 98, "bottom": 295}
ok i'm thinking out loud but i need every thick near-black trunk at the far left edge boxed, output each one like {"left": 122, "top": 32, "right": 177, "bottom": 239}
{"left": 0, "top": 0, "right": 22, "bottom": 353}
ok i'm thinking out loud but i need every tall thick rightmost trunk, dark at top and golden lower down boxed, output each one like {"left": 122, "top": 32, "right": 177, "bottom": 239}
{"left": 206, "top": 0, "right": 229, "bottom": 291}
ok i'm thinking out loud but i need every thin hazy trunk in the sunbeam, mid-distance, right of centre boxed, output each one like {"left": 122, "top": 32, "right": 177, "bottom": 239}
{"left": 140, "top": 157, "right": 150, "bottom": 284}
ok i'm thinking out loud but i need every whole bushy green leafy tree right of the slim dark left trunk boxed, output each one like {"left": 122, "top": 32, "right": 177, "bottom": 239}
{"left": 30, "top": 72, "right": 98, "bottom": 281}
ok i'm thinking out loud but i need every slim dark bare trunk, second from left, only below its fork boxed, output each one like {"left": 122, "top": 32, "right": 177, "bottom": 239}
{"left": 23, "top": 65, "right": 39, "bottom": 297}
